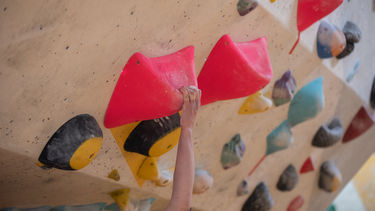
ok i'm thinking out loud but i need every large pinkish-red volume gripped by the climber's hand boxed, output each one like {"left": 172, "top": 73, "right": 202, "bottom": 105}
{"left": 104, "top": 46, "right": 197, "bottom": 128}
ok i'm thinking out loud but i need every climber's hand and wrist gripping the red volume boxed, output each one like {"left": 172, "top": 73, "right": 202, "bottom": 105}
{"left": 180, "top": 86, "right": 201, "bottom": 130}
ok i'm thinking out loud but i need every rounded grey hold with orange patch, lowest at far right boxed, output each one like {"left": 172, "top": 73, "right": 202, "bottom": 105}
{"left": 319, "top": 160, "right": 342, "bottom": 192}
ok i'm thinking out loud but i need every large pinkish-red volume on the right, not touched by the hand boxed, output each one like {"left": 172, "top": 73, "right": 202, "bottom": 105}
{"left": 198, "top": 35, "right": 272, "bottom": 105}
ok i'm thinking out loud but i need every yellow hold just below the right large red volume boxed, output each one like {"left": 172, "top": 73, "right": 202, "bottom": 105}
{"left": 238, "top": 91, "right": 272, "bottom": 114}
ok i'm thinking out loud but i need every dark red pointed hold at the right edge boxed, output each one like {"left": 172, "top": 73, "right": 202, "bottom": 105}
{"left": 342, "top": 106, "right": 374, "bottom": 143}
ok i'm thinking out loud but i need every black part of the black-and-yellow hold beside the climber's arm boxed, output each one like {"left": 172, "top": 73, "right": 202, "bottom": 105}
{"left": 124, "top": 113, "right": 180, "bottom": 156}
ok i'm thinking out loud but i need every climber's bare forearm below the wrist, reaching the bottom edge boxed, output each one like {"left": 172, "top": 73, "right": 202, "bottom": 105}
{"left": 168, "top": 127, "right": 195, "bottom": 211}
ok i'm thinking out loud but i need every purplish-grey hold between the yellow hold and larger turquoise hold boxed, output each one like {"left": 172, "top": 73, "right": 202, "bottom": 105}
{"left": 272, "top": 70, "right": 296, "bottom": 106}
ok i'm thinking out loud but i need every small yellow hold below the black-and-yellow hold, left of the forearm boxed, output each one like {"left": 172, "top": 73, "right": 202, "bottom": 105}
{"left": 138, "top": 157, "right": 159, "bottom": 181}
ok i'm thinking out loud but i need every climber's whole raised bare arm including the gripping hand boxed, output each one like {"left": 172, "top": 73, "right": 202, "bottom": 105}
{"left": 167, "top": 86, "right": 201, "bottom": 211}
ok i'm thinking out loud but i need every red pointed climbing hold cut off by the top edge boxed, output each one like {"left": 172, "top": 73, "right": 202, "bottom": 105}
{"left": 289, "top": 0, "right": 343, "bottom": 54}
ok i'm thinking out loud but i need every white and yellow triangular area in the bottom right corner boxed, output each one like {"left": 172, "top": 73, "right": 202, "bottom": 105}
{"left": 327, "top": 153, "right": 375, "bottom": 211}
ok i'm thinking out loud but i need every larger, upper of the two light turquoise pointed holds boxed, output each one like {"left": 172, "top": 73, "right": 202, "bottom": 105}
{"left": 288, "top": 77, "right": 324, "bottom": 127}
